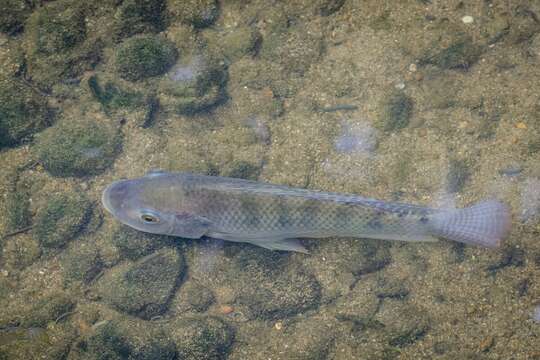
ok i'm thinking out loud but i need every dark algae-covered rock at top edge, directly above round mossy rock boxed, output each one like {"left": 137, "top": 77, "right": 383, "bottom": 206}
{"left": 115, "top": 0, "right": 166, "bottom": 37}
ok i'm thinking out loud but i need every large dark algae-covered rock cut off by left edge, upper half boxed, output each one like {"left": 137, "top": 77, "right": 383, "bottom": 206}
{"left": 0, "top": 77, "right": 52, "bottom": 149}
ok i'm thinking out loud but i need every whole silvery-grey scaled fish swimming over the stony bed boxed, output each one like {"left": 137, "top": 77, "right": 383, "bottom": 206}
{"left": 102, "top": 171, "right": 510, "bottom": 252}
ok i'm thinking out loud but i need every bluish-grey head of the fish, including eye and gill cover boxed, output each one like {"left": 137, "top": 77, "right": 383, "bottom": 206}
{"left": 102, "top": 171, "right": 211, "bottom": 239}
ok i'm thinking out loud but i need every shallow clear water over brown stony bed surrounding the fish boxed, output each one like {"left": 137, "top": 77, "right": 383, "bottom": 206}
{"left": 0, "top": 0, "right": 540, "bottom": 359}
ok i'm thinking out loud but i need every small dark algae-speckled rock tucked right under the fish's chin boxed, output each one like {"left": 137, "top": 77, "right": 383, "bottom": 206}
{"left": 111, "top": 226, "right": 174, "bottom": 260}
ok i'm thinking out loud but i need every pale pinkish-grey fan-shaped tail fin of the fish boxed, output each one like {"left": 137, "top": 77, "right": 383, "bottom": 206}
{"left": 431, "top": 200, "right": 510, "bottom": 248}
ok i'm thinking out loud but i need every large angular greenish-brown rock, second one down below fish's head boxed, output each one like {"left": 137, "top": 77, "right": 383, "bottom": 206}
{"left": 98, "top": 248, "right": 184, "bottom": 319}
